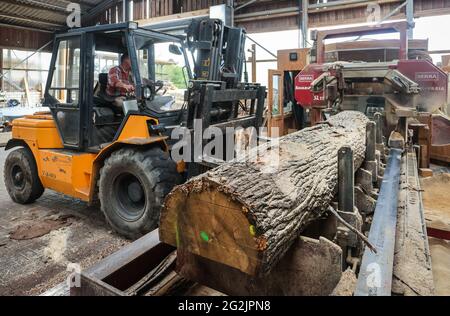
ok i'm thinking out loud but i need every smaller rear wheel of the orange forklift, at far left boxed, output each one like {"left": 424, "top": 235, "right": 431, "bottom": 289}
{"left": 3, "top": 148, "right": 44, "bottom": 204}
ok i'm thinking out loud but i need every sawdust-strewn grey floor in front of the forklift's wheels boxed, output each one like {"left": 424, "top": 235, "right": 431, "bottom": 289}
{"left": 0, "top": 148, "right": 128, "bottom": 295}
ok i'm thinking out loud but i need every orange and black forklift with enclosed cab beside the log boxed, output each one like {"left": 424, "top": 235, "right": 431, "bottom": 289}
{"left": 4, "top": 19, "right": 265, "bottom": 239}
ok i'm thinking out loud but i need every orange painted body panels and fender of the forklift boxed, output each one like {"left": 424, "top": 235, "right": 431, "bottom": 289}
{"left": 12, "top": 114, "right": 168, "bottom": 202}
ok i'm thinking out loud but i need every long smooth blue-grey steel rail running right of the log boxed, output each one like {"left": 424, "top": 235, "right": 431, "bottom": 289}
{"left": 355, "top": 149, "right": 402, "bottom": 296}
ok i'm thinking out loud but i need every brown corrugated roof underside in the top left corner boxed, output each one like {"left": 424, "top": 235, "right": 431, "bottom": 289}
{"left": 0, "top": 0, "right": 105, "bottom": 31}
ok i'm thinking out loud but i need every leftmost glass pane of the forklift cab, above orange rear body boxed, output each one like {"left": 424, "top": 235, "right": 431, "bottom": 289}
{"left": 49, "top": 37, "right": 81, "bottom": 107}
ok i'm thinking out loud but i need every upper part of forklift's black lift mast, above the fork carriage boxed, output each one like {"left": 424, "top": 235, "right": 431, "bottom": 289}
{"left": 187, "top": 19, "right": 245, "bottom": 89}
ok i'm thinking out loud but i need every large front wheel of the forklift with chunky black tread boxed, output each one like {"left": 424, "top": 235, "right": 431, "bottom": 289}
{"left": 99, "top": 148, "right": 181, "bottom": 239}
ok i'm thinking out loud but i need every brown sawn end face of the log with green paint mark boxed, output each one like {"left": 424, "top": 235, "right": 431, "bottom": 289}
{"left": 160, "top": 179, "right": 267, "bottom": 275}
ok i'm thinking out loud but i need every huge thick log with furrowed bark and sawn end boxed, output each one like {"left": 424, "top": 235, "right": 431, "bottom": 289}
{"left": 160, "top": 111, "right": 368, "bottom": 275}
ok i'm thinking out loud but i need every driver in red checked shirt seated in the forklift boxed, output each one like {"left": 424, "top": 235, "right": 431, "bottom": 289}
{"left": 106, "top": 53, "right": 135, "bottom": 109}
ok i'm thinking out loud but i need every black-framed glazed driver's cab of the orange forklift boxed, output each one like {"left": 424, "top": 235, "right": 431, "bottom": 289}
{"left": 44, "top": 22, "right": 192, "bottom": 151}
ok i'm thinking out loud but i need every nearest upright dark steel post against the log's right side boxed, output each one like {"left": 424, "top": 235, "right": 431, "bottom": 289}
{"left": 338, "top": 146, "right": 355, "bottom": 213}
